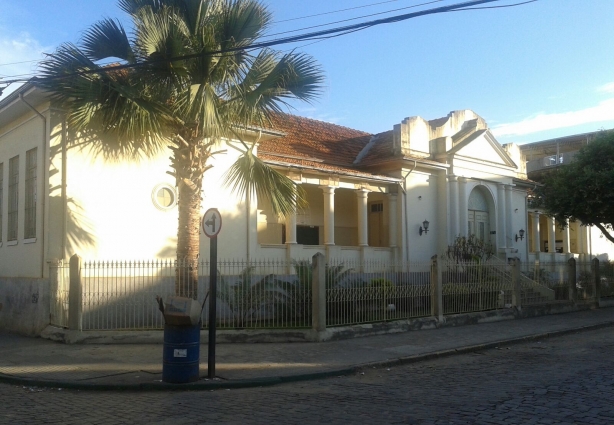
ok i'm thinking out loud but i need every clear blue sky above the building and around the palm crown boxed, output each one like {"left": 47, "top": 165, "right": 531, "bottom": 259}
{"left": 0, "top": 0, "right": 614, "bottom": 143}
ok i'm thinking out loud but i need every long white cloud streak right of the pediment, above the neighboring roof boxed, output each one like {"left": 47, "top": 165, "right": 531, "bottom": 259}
{"left": 492, "top": 98, "right": 614, "bottom": 137}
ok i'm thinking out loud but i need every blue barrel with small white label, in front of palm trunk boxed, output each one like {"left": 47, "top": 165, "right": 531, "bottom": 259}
{"left": 162, "top": 324, "right": 200, "bottom": 384}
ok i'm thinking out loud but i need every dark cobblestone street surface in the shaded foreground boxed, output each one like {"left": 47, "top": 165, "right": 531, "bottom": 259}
{"left": 0, "top": 328, "right": 614, "bottom": 425}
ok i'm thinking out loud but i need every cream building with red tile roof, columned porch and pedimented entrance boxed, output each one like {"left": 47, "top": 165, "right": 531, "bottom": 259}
{"left": 0, "top": 85, "right": 533, "bottom": 284}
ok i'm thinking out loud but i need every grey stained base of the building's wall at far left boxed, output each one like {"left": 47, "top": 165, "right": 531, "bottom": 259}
{"left": 0, "top": 277, "right": 50, "bottom": 335}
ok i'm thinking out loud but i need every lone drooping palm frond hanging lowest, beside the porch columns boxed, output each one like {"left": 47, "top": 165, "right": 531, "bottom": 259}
{"left": 224, "top": 150, "right": 307, "bottom": 215}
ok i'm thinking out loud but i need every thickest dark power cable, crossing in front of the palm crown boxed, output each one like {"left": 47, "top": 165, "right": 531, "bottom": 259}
{"left": 2, "top": 0, "right": 537, "bottom": 84}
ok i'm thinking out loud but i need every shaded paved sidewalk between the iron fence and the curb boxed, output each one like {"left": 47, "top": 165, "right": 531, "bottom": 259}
{"left": 0, "top": 308, "right": 614, "bottom": 390}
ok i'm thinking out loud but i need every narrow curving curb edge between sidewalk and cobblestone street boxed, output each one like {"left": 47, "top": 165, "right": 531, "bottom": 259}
{"left": 0, "top": 321, "right": 614, "bottom": 391}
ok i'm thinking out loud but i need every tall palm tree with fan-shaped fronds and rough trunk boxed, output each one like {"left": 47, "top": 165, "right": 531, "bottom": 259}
{"left": 37, "top": 0, "right": 323, "bottom": 298}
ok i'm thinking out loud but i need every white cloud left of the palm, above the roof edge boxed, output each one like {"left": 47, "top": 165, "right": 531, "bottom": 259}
{"left": 0, "top": 33, "right": 50, "bottom": 96}
